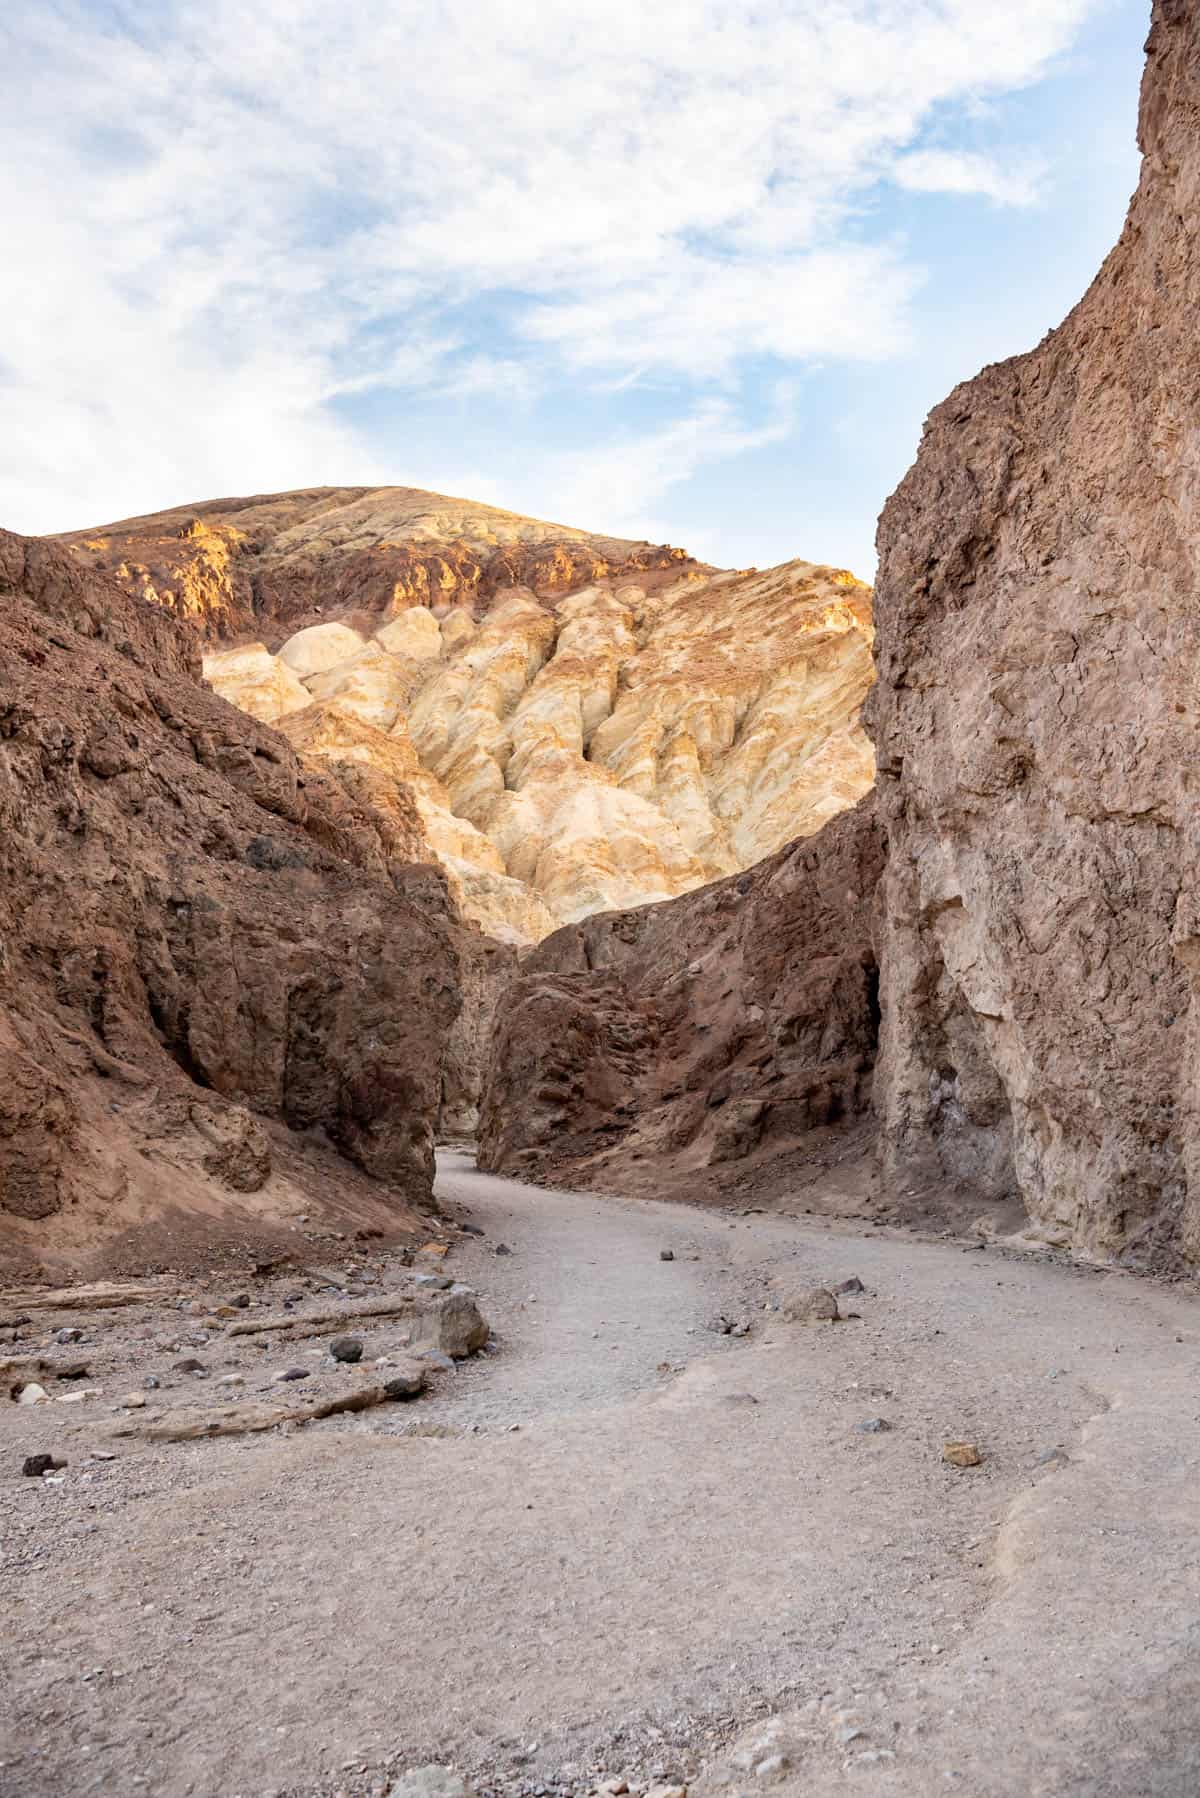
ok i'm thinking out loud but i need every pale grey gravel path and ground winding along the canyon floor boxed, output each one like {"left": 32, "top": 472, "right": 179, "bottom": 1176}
{"left": 0, "top": 1156, "right": 1200, "bottom": 1798}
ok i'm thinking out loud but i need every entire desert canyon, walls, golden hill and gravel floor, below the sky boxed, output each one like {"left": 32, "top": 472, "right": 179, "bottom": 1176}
{"left": 0, "top": 0, "right": 1200, "bottom": 1798}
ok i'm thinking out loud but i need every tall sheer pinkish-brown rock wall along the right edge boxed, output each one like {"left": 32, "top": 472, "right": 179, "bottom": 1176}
{"left": 873, "top": 0, "right": 1200, "bottom": 1266}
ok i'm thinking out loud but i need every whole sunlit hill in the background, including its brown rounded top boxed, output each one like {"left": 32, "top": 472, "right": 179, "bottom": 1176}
{"left": 56, "top": 489, "right": 874, "bottom": 944}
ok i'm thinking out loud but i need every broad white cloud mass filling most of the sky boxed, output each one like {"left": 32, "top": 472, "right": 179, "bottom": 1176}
{"left": 0, "top": 0, "right": 1094, "bottom": 530}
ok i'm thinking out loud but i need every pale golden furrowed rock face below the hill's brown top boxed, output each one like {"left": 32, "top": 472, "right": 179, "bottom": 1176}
{"left": 170, "top": 521, "right": 873, "bottom": 942}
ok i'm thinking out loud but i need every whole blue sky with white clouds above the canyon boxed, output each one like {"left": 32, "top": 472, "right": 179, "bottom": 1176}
{"left": 0, "top": 0, "right": 1150, "bottom": 579}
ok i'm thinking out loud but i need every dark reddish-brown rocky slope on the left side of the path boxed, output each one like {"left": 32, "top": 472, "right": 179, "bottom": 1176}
{"left": 0, "top": 534, "right": 461, "bottom": 1269}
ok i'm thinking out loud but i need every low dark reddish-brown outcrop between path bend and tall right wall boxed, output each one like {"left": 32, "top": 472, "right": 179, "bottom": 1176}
{"left": 479, "top": 798, "right": 882, "bottom": 1197}
